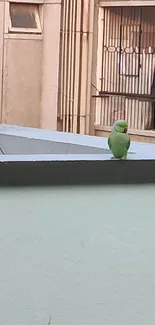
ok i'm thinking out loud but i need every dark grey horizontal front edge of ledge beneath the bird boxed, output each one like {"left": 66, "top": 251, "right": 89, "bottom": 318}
{"left": 0, "top": 160, "right": 155, "bottom": 186}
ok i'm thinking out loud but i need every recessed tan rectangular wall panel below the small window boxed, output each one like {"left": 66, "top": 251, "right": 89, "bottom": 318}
{"left": 2, "top": 39, "right": 42, "bottom": 127}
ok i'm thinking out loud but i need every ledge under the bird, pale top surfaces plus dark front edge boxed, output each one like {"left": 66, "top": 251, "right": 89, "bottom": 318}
{"left": 0, "top": 124, "right": 155, "bottom": 185}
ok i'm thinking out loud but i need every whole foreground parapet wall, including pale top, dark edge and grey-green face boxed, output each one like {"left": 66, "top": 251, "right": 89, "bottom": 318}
{"left": 0, "top": 125, "right": 155, "bottom": 325}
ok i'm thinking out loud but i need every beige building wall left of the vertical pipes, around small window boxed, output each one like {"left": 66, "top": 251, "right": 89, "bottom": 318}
{"left": 0, "top": 0, "right": 61, "bottom": 129}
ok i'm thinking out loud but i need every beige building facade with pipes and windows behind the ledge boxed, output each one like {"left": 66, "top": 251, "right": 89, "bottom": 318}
{"left": 0, "top": 0, "right": 155, "bottom": 142}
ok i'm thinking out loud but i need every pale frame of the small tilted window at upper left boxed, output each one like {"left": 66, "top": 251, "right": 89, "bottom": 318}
{"left": 8, "top": 1, "right": 42, "bottom": 34}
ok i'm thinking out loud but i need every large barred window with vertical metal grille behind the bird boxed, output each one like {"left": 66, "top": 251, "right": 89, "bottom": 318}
{"left": 98, "top": 7, "right": 155, "bottom": 129}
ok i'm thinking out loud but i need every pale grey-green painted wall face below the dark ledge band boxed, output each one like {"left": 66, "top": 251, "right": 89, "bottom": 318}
{"left": 0, "top": 186, "right": 155, "bottom": 325}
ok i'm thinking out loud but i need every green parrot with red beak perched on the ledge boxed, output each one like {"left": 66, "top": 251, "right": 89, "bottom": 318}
{"left": 108, "top": 120, "right": 130, "bottom": 160}
